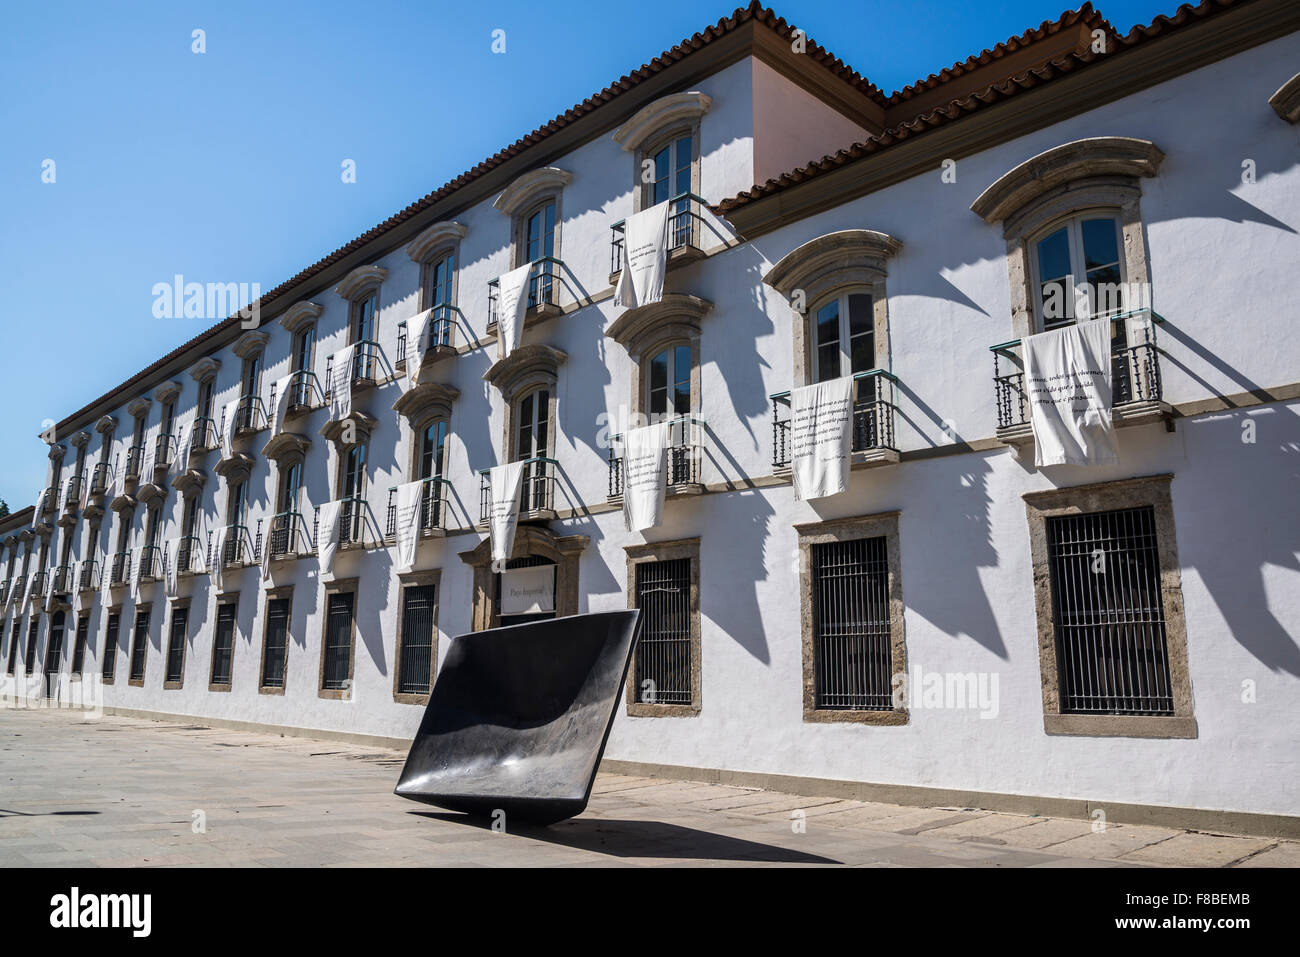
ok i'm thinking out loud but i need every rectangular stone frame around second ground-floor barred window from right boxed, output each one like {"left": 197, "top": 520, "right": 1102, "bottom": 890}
{"left": 794, "top": 511, "right": 910, "bottom": 727}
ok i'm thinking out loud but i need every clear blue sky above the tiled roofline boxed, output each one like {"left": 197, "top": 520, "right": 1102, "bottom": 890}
{"left": 0, "top": 0, "right": 1177, "bottom": 510}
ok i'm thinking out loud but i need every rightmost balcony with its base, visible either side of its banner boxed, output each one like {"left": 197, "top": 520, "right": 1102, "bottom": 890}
{"left": 989, "top": 309, "right": 1173, "bottom": 446}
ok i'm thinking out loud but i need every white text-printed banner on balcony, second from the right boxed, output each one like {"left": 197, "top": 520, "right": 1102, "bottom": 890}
{"left": 790, "top": 376, "right": 853, "bottom": 502}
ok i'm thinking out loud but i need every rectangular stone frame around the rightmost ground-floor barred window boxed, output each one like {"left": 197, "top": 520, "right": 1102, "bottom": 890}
{"left": 1023, "top": 473, "right": 1197, "bottom": 737}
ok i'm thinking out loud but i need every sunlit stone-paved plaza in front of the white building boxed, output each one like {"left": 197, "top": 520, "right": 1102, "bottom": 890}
{"left": 0, "top": 710, "right": 1300, "bottom": 867}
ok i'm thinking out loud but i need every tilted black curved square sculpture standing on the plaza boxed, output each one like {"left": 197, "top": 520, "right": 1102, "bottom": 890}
{"left": 395, "top": 609, "right": 641, "bottom": 824}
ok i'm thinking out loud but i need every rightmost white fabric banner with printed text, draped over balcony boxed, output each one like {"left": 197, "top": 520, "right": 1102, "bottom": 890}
{"left": 1021, "top": 319, "right": 1119, "bottom": 467}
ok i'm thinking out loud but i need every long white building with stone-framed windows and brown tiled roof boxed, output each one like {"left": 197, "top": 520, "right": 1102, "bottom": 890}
{"left": 0, "top": 0, "right": 1300, "bottom": 833}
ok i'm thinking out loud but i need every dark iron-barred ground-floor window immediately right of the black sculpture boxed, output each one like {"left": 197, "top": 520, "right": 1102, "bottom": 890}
{"left": 636, "top": 558, "right": 694, "bottom": 705}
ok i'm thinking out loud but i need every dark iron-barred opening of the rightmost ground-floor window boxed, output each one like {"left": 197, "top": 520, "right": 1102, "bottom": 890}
{"left": 1047, "top": 506, "right": 1174, "bottom": 715}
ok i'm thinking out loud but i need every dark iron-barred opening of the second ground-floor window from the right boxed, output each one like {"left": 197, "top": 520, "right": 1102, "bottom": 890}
{"left": 810, "top": 536, "right": 893, "bottom": 711}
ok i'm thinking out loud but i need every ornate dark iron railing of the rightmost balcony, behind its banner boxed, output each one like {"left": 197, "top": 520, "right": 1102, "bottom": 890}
{"left": 989, "top": 309, "right": 1165, "bottom": 429}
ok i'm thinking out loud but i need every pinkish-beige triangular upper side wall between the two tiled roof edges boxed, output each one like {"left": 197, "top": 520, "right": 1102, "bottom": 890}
{"left": 750, "top": 57, "right": 868, "bottom": 183}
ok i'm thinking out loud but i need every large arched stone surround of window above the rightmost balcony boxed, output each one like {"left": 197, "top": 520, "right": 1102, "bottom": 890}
{"left": 971, "top": 137, "right": 1165, "bottom": 338}
